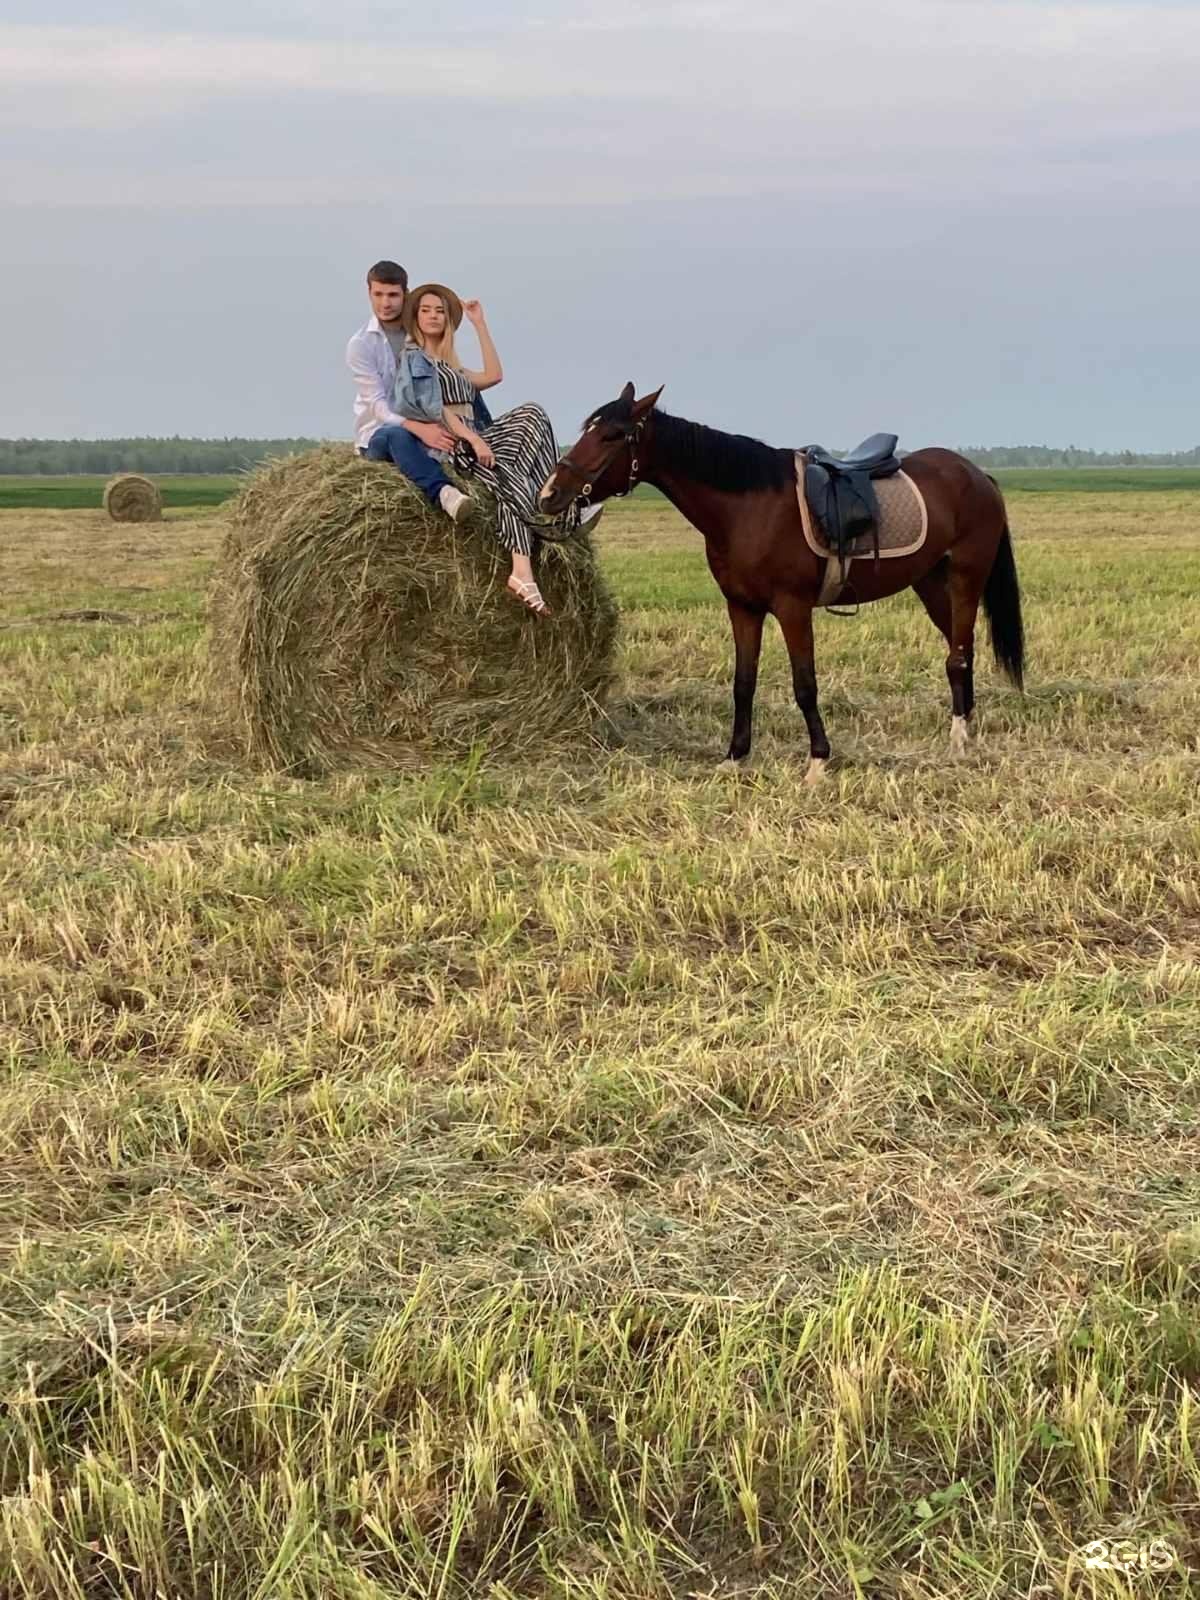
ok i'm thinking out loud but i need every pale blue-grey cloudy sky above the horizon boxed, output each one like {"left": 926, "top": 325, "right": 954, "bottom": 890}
{"left": 0, "top": 0, "right": 1200, "bottom": 450}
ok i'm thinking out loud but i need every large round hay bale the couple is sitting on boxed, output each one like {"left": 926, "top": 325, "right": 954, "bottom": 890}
{"left": 208, "top": 445, "right": 616, "bottom": 771}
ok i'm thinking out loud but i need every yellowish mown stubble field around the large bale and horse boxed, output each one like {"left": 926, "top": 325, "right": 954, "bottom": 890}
{"left": 0, "top": 490, "right": 1200, "bottom": 1600}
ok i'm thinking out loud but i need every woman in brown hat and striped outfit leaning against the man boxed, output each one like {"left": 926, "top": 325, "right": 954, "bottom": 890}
{"left": 405, "top": 283, "right": 602, "bottom": 616}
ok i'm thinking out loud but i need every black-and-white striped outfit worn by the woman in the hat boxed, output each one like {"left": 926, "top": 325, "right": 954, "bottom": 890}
{"left": 434, "top": 360, "right": 579, "bottom": 555}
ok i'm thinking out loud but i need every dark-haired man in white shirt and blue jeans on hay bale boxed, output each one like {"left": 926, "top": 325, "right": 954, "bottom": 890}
{"left": 346, "top": 261, "right": 490, "bottom": 525}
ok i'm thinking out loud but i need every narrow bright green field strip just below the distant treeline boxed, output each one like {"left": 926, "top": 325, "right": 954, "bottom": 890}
{"left": 0, "top": 467, "right": 1200, "bottom": 510}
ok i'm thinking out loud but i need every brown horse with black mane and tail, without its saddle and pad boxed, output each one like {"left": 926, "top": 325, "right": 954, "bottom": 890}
{"left": 539, "top": 384, "right": 1024, "bottom": 782}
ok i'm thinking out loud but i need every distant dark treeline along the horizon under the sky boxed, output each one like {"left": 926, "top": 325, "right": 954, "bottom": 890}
{"left": 0, "top": 437, "right": 1200, "bottom": 477}
